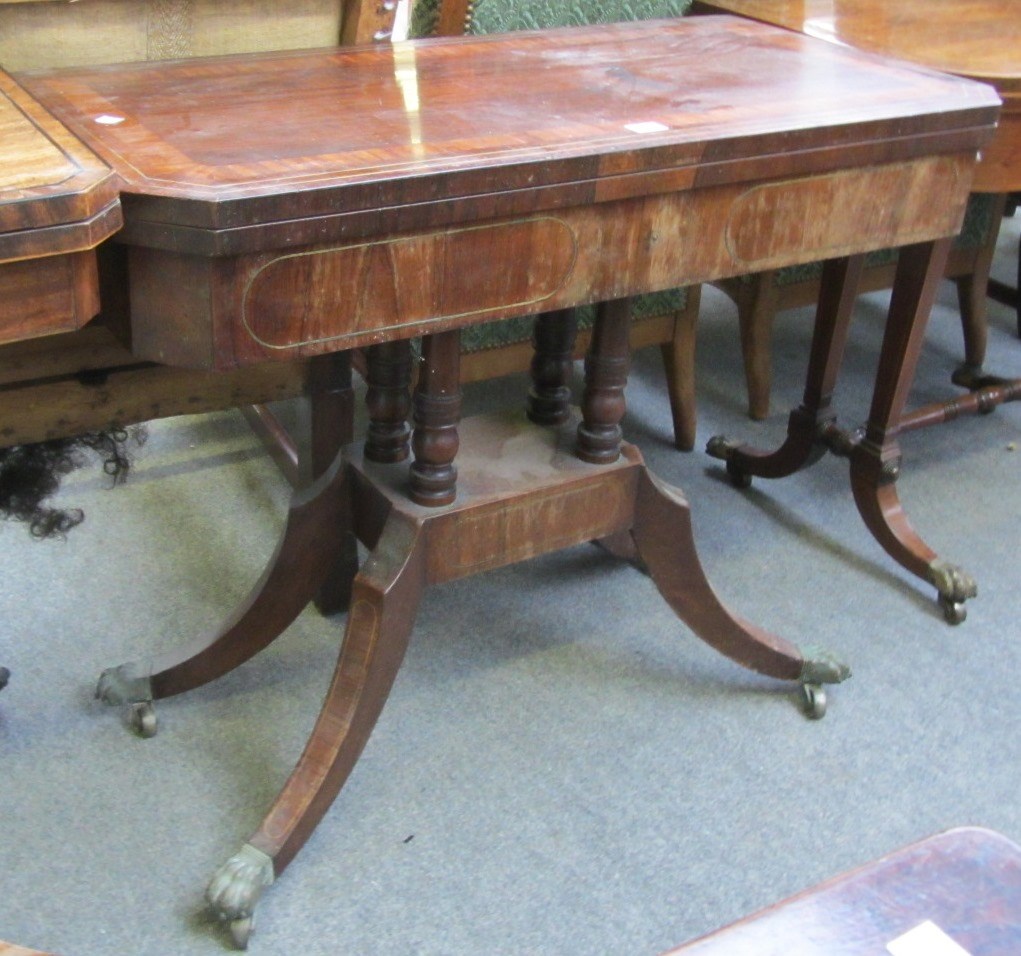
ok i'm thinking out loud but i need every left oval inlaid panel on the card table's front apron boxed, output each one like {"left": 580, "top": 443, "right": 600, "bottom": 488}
{"left": 242, "top": 217, "right": 578, "bottom": 349}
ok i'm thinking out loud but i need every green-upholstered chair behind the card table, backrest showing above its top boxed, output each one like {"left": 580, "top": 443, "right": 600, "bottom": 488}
{"left": 410, "top": 0, "right": 700, "bottom": 450}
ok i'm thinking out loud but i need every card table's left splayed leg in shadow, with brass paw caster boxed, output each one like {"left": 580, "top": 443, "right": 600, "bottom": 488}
{"left": 96, "top": 355, "right": 353, "bottom": 736}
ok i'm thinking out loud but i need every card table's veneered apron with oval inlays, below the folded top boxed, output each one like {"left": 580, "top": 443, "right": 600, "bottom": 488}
{"left": 130, "top": 152, "right": 974, "bottom": 370}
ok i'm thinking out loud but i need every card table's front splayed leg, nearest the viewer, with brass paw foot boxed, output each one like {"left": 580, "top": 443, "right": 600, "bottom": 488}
{"left": 206, "top": 515, "right": 426, "bottom": 948}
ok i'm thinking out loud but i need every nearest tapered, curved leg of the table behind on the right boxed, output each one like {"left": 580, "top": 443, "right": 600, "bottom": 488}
{"left": 850, "top": 239, "right": 978, "bottom": 624}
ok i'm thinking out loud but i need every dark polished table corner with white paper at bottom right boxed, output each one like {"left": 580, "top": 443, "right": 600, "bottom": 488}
{"left": 664, "top": 827, "right": 1021, "bottom": 956}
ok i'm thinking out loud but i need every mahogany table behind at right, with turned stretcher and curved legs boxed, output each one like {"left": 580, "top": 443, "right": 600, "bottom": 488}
{"left": 692, "top": 0, "right": 1021, "bottom": 624}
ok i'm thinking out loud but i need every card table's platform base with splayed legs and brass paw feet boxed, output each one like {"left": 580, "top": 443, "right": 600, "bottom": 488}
{"left": 100, "top": 415, "right": 849, "bottom": 946}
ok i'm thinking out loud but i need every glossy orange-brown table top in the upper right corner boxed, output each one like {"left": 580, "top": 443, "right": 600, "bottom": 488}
{"left": 696, "top": 0, "right": 1021, "bottom": 192}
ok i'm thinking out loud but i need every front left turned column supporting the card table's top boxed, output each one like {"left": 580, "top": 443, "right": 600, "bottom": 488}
{"left": 410, "top": 330, "right": 460, "bottom": 507}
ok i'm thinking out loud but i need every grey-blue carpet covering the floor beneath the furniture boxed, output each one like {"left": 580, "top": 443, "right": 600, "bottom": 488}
{"left": 0, "top": 212, "right": 1021, "bottom": 956}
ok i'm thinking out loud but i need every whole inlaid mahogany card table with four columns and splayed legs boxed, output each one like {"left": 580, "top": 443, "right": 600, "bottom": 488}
{"left": 15, "top": 17, "right": 999, "bottom": 943}
